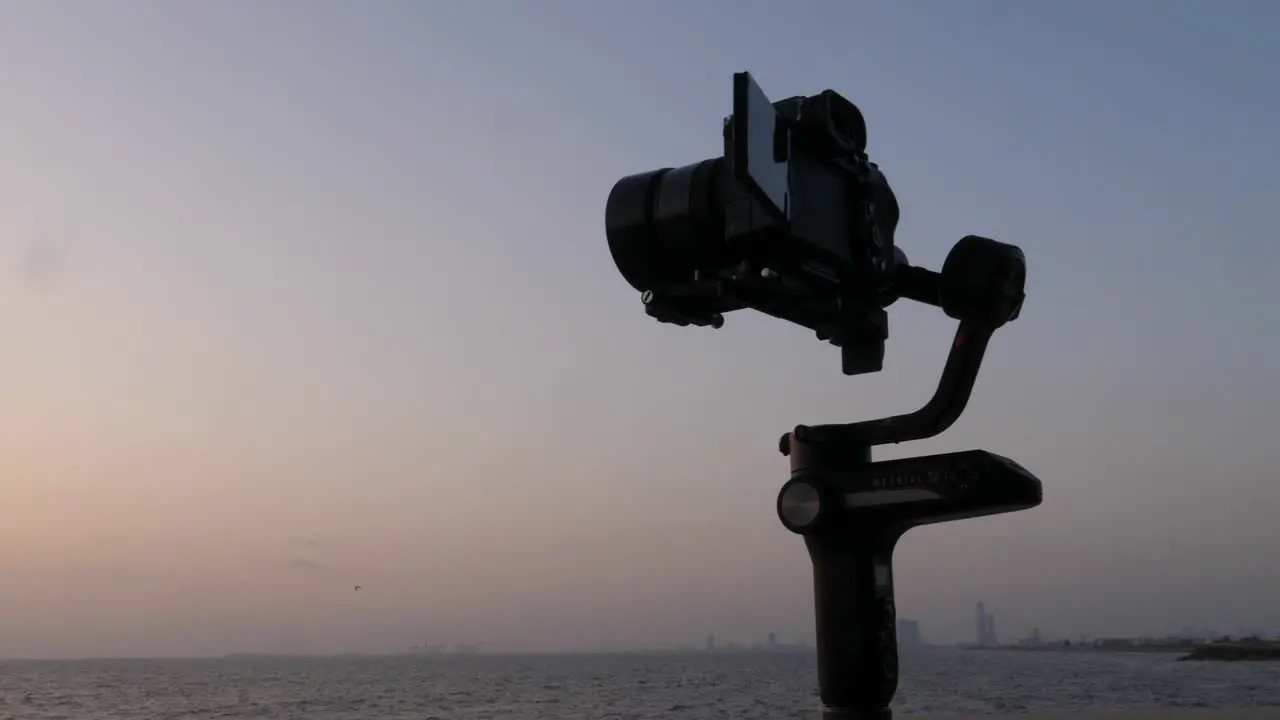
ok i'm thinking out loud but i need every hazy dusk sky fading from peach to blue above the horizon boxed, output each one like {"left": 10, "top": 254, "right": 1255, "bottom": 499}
{"left": 0, "top": 0, "right": 1280, "bottom": 657}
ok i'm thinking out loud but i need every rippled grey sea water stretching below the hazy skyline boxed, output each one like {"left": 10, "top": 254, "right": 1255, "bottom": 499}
{"left": 0, "top": 650, "right": 1280, "bottom": 720}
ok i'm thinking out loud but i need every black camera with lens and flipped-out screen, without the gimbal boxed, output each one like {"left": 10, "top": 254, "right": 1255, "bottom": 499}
{"left": 605, "top": 73, "right": 911, "bottom": 374}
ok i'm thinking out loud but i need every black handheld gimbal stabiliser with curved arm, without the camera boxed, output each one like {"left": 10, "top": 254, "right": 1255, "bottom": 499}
{"left": 778, "top": 236, "right": 1042, "bottom": 720}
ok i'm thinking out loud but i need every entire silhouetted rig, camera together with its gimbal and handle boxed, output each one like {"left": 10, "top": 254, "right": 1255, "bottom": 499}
{"left": 605, "top": 73, "right": 1042, "bottom": 720}
